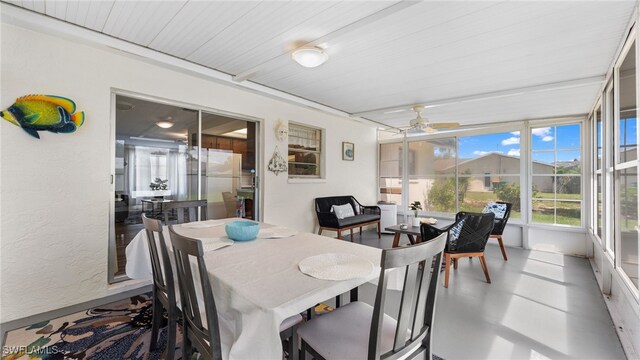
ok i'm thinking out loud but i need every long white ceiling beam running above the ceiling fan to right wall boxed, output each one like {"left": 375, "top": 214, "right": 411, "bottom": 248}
{"left": 350, "top": 75, "right": 605, "bottom": 117}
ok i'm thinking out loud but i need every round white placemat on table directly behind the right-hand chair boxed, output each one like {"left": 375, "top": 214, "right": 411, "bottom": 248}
{"left": 298, "top": 253, "right": 374, "bottom": 281}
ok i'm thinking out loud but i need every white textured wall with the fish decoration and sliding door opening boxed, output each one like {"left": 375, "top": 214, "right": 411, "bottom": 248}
{"left": 0, "top": 24, "right": 376, "bottom": 323}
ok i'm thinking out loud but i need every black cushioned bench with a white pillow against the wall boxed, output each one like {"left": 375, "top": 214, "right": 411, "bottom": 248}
{"left": 315, "top": 195, "right": 380, "bottom": 241}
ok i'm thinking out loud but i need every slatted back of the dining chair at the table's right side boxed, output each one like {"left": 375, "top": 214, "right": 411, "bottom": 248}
{"left": 368, "top": 233, "right": 447, "bottom": 360}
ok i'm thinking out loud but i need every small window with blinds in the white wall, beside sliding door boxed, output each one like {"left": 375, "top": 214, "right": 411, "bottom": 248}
{"left": 288, "top": 123, "right": 322, "bottom": 178}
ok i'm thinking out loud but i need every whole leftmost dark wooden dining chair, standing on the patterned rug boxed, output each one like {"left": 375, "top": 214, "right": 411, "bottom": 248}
{"left": 142, "top": 214, "right": 178, "bottom": 360}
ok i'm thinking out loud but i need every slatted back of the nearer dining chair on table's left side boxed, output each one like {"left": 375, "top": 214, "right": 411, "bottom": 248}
{"left": 169, "top": 225, "right": 222, "bottom": 360}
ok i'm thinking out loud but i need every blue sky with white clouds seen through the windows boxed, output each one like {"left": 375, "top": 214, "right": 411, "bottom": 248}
{"left": 458, "top": 122, "right": 588, "bottom": 163}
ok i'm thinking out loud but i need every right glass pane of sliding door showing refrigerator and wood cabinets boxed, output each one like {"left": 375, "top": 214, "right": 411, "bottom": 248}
{"left": 200, "top": 112, "right": 258, "bottom": 219}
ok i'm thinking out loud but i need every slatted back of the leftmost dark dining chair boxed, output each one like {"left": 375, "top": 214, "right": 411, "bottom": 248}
{"left": 142, "top": 214, "right": 175, "bottom": 303}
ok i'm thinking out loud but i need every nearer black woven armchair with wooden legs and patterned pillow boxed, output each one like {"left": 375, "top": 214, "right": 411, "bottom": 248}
{"left": 420, "top": 211, "right": 495, "bottom": 288}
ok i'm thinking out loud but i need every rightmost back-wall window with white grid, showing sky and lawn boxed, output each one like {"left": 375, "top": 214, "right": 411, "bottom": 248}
{"left": 531, "top": 124, "right": 582, "bottom": 226}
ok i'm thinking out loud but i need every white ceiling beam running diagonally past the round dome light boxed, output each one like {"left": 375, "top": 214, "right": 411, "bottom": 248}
{"left": 233, "top": 0, "right": 420, "bottom": 82}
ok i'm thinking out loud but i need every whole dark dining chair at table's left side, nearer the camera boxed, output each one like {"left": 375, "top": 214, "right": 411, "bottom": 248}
{"left": 169, "top": 225, "right": 302, "bottom": 360}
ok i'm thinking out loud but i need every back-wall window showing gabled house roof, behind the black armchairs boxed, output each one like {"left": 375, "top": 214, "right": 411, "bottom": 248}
{"left": 458, "top": 131, "right": 520, "bottom": 219}
